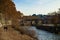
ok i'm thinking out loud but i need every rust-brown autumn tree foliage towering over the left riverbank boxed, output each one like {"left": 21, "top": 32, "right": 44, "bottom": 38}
{"left": 0, "top": 0, "right": 22, "bottom": 26}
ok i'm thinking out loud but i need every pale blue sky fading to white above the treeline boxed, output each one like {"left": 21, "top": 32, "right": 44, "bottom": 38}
{"left": 13, "top": 0, "right": 60, "bottom": 15}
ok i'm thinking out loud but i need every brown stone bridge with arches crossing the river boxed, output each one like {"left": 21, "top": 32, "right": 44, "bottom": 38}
{"left": 20, "top": 16, "right": 42, "bottom": 26}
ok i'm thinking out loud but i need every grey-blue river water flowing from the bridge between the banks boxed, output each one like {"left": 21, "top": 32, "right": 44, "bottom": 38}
{"left": 28, "top": 27, "right": 60, "bottom": 40}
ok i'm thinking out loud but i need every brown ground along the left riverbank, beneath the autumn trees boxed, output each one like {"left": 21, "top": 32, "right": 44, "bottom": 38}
{"left": 0, "top": 27, "right": 35, "bottom": 40}
